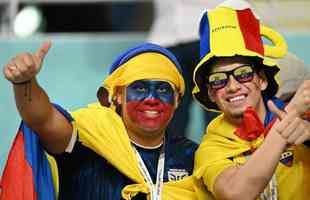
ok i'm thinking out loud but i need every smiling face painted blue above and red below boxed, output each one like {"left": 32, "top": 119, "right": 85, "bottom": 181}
{"left": 126, "top": 80, "right": 175, "bottom": 130}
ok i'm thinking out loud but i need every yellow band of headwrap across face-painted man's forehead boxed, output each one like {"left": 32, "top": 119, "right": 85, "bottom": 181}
{"left": 103, "top": 52, "right": 185, "bottom": 97}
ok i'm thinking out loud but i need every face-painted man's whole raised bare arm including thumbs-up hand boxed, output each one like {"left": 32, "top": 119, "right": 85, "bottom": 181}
{"left": 3, "top": 41, "right": 73, "bottom": 153}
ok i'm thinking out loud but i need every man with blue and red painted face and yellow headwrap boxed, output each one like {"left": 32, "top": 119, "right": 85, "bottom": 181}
{"left": 1, "top": 42, "right": 211, "bottom": 200}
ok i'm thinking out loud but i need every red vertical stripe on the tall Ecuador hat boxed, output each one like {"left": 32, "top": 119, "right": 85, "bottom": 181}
{"left": 237, "top": 9, "right": 264, "bottom": 56}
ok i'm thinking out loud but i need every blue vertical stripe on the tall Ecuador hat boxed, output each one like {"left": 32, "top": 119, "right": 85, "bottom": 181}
{"left": 199, "top": 11, "right": 210, "bottom": 59}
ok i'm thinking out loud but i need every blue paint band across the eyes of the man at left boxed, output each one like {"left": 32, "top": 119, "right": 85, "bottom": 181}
{"left": 126, "top": 80, "right": 175, "bottom": 105}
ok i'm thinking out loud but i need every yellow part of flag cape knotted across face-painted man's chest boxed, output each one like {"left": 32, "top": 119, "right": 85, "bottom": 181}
{"left": 72, "top": 104, "right": 211, "bottom": 200}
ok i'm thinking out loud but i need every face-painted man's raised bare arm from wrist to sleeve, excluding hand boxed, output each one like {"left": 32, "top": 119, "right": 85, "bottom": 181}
{"left": 13, "top": 79, "right": 72, "bottom": 153}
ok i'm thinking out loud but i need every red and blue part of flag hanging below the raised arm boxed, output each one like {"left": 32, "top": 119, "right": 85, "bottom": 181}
{"left": 0, "top": 122, "right": 56, "bottom": 200}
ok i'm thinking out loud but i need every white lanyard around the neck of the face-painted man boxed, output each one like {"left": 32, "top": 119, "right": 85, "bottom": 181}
{"left": 132, "top": 143, "right": 165, "bottom": 200}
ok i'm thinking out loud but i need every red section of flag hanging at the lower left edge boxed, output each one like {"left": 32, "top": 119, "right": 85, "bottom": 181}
{"left": 0, "top": 132, "right": 37, "bottom": 200}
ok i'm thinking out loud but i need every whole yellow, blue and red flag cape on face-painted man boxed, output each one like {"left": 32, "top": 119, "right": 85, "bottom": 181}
{"left": 0, "top": 104, "right": 213, "bottom": 200}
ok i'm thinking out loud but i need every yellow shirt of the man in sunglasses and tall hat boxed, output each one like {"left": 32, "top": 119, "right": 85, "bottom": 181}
{"left": 194, "top": 99, "right": 310, "bottom": 200}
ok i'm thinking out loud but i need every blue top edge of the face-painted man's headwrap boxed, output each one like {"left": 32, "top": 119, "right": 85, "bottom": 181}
{"left": 108, "top": 43, "right": 182, "bottom": 74}
